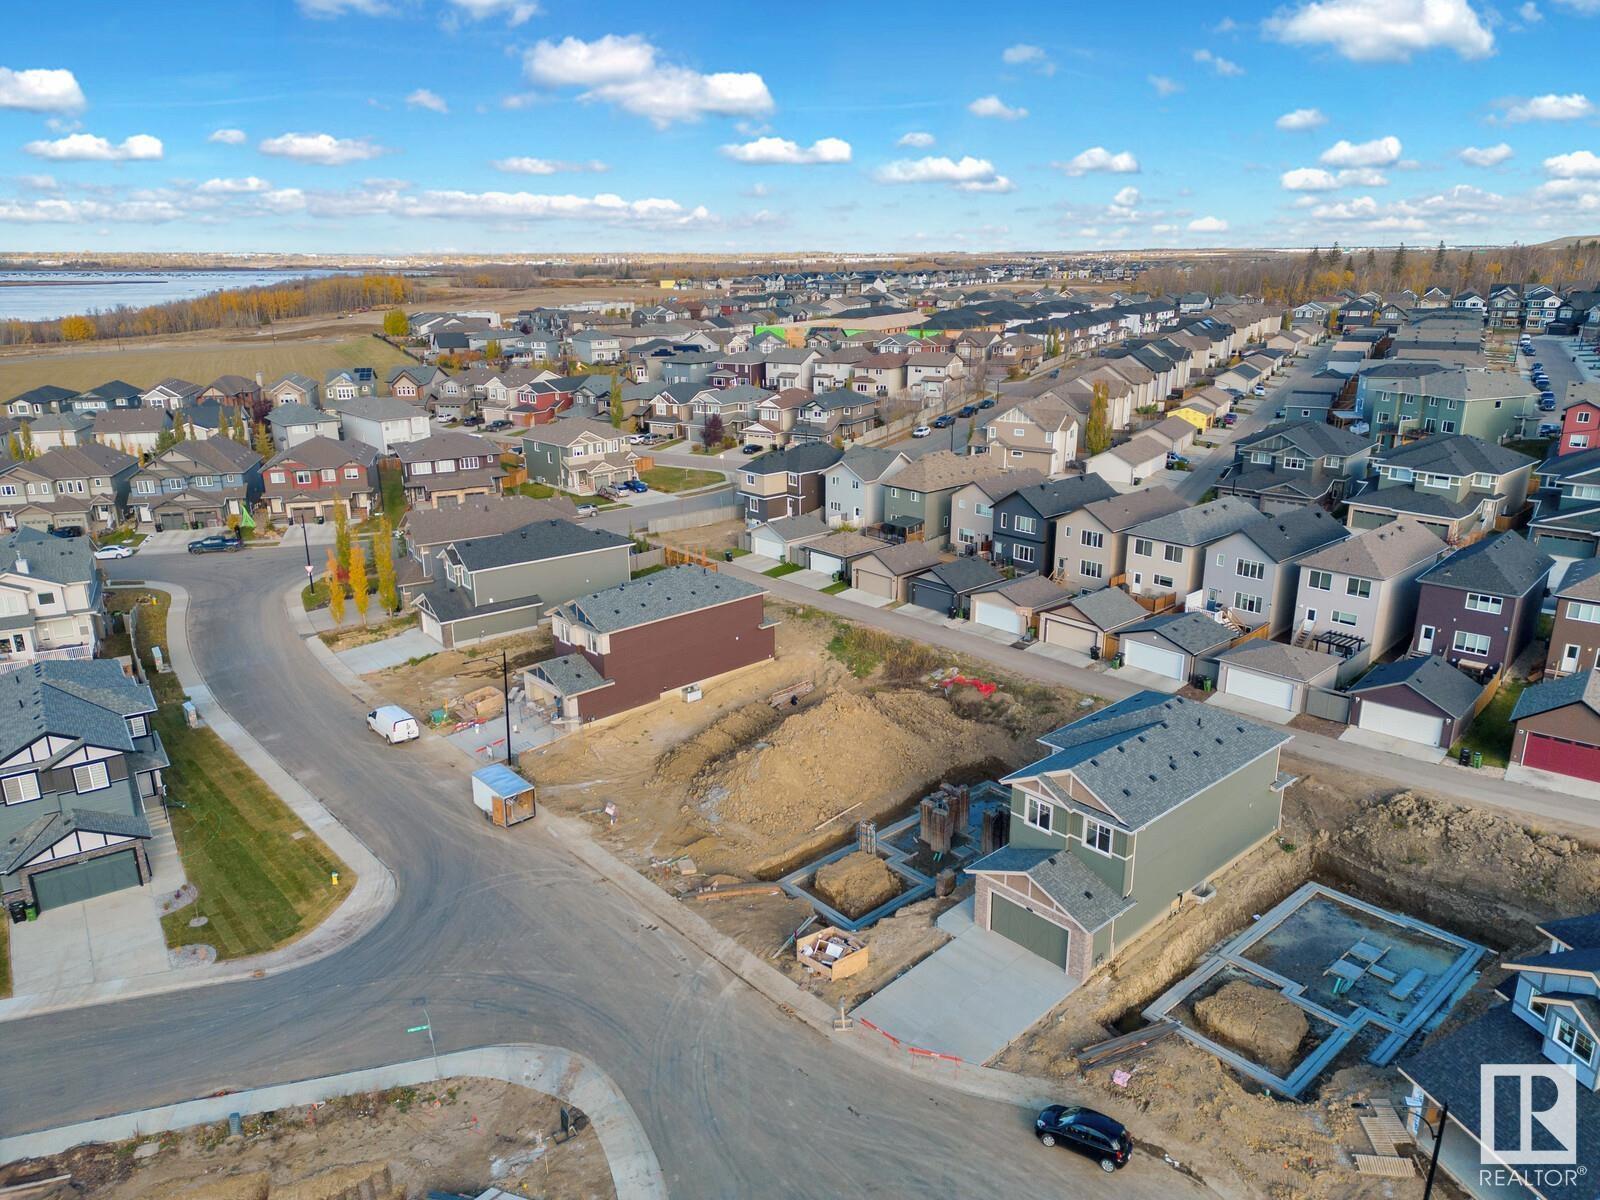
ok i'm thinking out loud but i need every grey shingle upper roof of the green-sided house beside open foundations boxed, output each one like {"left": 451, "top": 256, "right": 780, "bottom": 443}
{"left": 1002, "top": 691, "right": 1290, "bottom": 829}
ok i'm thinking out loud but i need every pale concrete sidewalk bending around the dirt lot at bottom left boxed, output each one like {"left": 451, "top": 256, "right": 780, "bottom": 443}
{"left": 0, "top": 1043, "right": 667, "bottom": 1200}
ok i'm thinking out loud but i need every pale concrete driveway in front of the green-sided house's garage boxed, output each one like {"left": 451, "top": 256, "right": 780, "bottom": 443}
{"left": 854, "top": 899, "right": 1077, "bottom": 1062}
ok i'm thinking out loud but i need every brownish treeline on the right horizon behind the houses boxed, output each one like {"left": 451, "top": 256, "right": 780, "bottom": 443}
{"left": 1138, "top": 238, "right": 1600, "bottom": 304}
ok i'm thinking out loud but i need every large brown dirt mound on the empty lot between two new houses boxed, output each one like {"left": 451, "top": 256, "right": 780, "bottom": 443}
{"left": 694, "top": 690, "right": 1016, "bottom": 837}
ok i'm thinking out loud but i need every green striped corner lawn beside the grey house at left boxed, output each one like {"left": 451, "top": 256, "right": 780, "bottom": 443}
{"left": 109, "top": 590, "right": 355, "bottom": 958}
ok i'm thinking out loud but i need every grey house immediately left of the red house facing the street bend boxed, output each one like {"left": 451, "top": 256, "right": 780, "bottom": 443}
{"left": 128, "top": 437, "right": 261, "bottom": 531}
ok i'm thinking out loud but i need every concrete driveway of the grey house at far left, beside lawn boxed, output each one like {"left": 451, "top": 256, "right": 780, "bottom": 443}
{"left": 11, "top": 885, "right": 168, "bottom": 995}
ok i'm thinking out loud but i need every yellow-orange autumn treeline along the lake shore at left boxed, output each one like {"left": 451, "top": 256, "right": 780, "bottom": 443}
{"left": 0, "top": 275, "right": 421, "bottom": 346}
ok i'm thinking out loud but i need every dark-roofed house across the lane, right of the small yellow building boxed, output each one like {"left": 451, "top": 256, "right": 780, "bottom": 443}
{"left": 1216, "top": 421, "right": 1373, "bottom": 514}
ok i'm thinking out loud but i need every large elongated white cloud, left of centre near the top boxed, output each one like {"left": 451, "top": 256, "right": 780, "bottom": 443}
{"left": 523, "top": 34, "right": 773, "bottom": 126}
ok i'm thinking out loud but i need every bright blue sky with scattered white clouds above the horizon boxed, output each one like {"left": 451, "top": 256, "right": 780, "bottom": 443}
{"left": 0, "top": 0, "right": 1600, "bottom": 254}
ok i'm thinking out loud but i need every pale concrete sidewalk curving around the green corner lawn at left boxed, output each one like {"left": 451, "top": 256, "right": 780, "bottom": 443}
{"left": 0, "top": 581, "right": 397, "bottom": 1021}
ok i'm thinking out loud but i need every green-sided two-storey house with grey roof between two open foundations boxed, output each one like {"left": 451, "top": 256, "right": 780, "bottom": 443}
{"left": 968, "top": 691, "right": 1290, "bottom": 981}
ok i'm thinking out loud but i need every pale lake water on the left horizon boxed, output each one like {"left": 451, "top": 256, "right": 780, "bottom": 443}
{"left": 0, "top": 270, "right": 350, "bottom": 322}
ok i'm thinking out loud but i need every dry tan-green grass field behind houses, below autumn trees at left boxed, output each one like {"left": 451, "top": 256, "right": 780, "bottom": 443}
{"left": 0, "top": 338, "right": 411, "bottom": 400}
